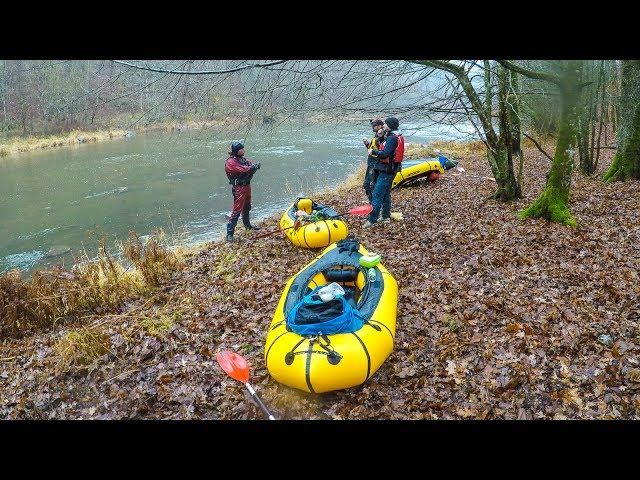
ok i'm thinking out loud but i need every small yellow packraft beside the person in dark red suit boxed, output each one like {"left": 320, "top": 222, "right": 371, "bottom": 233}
{"left": 280, "top": 198, "right": 349, "bottom": 248}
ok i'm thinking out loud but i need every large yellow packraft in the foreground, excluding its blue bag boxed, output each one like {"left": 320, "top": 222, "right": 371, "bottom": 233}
{"left": 264, "top": 239, "right": 398, "bottom": 393}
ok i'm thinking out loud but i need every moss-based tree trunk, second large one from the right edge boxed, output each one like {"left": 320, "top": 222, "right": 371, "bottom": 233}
{"left": 520, "top": 60, "right": 581, "bottom": 226}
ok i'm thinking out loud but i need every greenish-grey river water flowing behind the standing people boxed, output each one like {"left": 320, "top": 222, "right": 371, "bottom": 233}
{"left": 0, "top": 122, "right": 470, "bottom": 273}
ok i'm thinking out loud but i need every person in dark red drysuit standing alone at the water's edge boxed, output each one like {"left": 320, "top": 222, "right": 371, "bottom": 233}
{"left": 224, "top": 142, "right": 260, "bottom": 242}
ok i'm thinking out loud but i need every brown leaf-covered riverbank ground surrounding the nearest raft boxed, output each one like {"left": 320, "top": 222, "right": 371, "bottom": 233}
{"left": 0, "top": 144, "right": 640, "bottom": 419}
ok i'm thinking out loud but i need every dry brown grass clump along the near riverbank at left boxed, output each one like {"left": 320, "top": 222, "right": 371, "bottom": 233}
{"left": 0, "top": 233, "right": 182, "bottom": 339}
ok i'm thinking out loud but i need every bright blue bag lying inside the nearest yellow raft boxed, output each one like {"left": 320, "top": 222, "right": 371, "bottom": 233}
{"left": 287, "top": 285, "right": 364, "bottom": 335}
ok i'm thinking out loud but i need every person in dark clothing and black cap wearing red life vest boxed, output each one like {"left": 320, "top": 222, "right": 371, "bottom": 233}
{"left": 363, "top": 117, "right": 401, "bottom": 227}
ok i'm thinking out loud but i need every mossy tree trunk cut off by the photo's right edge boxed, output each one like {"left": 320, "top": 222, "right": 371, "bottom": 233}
{"left": 604, "top": 60, "right": 640, "bottom": 182}
